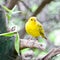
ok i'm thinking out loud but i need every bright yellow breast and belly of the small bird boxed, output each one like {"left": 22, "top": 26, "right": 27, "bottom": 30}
{"left": 25, "top": 24, "right": 40, "bottom": 37}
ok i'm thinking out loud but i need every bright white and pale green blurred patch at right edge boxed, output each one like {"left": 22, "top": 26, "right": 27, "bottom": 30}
{"left": 48, "top": 29, "right": 60, "bottom": 45}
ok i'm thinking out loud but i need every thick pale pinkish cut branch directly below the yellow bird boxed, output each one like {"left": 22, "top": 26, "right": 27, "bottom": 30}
{"left": 20, "top": 39, "right": 45, "bottom": 50}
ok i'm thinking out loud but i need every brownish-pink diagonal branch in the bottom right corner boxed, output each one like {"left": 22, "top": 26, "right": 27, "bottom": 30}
{"left": 42, "top": 47, "right": 60, "bottom": 60}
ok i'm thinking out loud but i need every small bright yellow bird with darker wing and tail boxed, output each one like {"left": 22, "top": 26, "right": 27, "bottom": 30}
{"left": 25, "top": 17, "right": 47, "bottom": 40}
